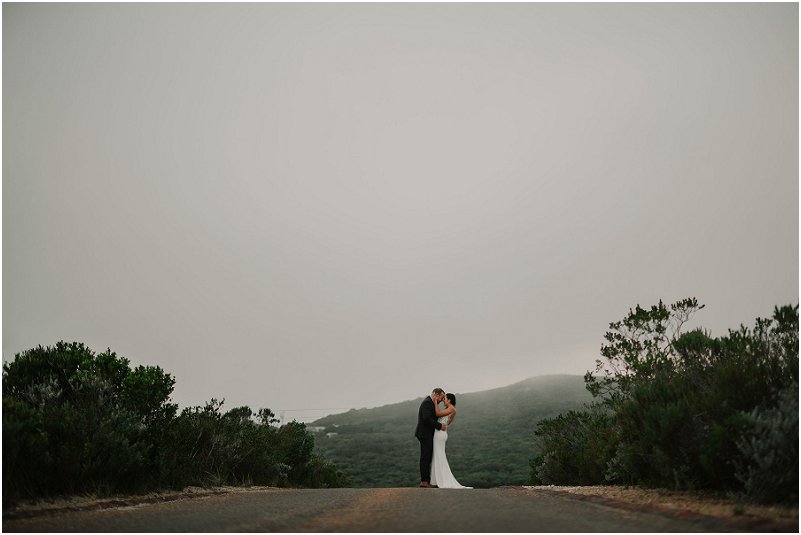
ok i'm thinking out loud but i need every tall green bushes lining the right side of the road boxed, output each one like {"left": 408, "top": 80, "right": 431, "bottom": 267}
{"left": 530, "top": 299, "right": 798, "bottom": 502}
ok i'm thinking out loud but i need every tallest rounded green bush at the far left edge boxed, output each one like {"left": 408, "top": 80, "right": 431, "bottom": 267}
{"left": 3, "top": 342, "right": 158, "bottom": 503}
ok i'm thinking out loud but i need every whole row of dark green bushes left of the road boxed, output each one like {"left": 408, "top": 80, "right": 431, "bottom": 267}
{"left": 3, "top": 342, "right": 347, "bottom": 504}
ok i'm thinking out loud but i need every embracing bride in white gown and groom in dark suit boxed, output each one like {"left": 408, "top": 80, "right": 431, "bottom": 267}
{"left": 414, "top": 388, "right": 473, "bottom": 489}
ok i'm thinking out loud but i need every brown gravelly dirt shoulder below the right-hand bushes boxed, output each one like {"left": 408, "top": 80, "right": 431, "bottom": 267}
{"left": 523, "top": 485, "right": 798, "bottom": 531}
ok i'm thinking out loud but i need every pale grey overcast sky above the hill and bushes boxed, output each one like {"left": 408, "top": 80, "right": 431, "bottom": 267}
{"left": 2, "top": 3, "right": 799, "bottom": 421}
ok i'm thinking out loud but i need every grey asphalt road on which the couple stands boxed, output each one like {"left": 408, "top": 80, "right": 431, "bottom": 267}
{"left": 3, "top": 487, "right": 760, "bottom": 532}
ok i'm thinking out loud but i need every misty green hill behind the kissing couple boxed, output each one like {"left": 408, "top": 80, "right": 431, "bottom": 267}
{"left": 309, "top": 375, "right": 591, "bottom": 487}
